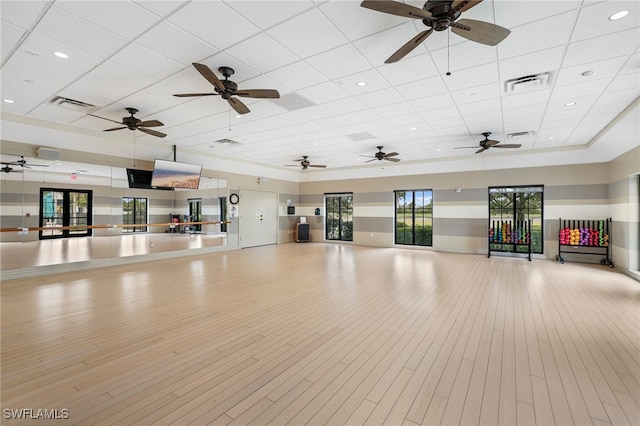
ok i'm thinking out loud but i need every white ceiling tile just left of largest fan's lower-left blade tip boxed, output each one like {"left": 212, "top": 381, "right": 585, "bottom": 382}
{"left": 306, "top": 44, "right": 371, "bottom": 80}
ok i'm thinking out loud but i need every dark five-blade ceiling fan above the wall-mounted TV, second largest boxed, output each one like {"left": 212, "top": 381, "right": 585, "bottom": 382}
{"left": 173, "top": 62, "right": 280, "bottom": 114}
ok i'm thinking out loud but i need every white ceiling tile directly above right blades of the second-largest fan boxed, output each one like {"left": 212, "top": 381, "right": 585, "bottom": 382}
{"left": 226, "top": 33, "right": 299, "bottom": 73}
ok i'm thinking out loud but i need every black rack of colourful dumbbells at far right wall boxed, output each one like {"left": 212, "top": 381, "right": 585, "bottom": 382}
{"left": 556, "top": 218, "right": 614, "bottom": 268}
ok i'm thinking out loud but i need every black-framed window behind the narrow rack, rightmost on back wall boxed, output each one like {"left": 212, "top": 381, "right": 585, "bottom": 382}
{"left": 489, "top": 185, "right": 544, "bottom": 254}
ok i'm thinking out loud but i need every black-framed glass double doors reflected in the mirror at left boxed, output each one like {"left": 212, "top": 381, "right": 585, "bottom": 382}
{"left": 39, "top": 188, "right": 92, "bottom": 239}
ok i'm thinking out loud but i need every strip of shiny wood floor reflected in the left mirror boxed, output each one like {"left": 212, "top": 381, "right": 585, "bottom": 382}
{"left": 0, "top": 233, "right": 227, "bottom": 271}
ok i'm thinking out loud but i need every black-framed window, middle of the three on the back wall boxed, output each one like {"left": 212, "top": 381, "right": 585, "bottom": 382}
{"left": 394, "top": 189, "right": 433, "bottom": 246}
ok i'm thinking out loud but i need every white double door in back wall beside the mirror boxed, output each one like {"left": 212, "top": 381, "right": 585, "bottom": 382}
{"left": 238, "top": 190, "right": 278, "bottom": 248}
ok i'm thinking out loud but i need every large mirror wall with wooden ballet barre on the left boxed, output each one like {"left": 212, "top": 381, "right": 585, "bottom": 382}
{"left": 0, "top": 156, "right": 227, "bottom": 272}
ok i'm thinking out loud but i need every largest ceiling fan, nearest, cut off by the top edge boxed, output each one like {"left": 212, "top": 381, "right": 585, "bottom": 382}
{"left": 360, "top": 0, "right": 511, "bottom": 64}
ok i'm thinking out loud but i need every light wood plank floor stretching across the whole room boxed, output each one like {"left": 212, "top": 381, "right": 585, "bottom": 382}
{"left": 1, "top": 243, "right": 640, "bottom": 425}
